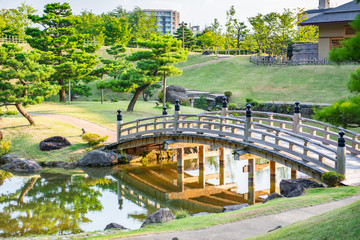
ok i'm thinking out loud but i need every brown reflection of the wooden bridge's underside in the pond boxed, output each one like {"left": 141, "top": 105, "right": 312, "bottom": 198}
{"left": 112, "top": 158, "right": 270, "bottom": 212}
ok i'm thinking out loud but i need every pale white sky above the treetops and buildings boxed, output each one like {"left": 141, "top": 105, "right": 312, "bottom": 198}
{"left": 0, "top": 0, "right": 350, "bottom": 29}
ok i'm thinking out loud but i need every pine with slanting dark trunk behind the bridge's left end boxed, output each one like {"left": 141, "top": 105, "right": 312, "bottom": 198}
{"left": 107, "top": 34, "right": 188, "bottom": 111}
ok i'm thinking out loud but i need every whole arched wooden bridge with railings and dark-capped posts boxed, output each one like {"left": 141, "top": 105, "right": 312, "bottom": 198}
{"left": 108, "top": 100, "right": 360, "bottom": 184}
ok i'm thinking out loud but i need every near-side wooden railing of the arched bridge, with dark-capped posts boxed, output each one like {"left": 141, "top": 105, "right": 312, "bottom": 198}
{"left": 118, "top": 100, "right": 345, "bottom": 174}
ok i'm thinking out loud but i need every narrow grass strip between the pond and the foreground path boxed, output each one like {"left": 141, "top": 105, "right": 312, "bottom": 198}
{"left": 81, "top": 187, "right": 360, "bottom": 239}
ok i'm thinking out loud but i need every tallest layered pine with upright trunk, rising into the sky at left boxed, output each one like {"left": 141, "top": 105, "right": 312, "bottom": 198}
{"left": 26, "top": 3, "right": 100, "bottom": 102}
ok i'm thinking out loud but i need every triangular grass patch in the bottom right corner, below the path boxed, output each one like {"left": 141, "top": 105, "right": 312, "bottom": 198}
{"left": 251, "top": 198, "right": 360, "bottom": 240}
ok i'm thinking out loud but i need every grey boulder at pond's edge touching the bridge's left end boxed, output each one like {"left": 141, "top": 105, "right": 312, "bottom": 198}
{"left": 78, "top": 150, "right": 119, "bottom": 167}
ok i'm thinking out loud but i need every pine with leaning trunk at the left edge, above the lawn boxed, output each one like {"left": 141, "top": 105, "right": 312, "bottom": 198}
{"left": 0, "top": 44, "right": 59, "bottom": 125}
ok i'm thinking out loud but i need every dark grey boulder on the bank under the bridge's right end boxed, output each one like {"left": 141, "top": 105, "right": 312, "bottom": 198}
{"left": 280, "top": 178, "right": 324, "bottom": 198}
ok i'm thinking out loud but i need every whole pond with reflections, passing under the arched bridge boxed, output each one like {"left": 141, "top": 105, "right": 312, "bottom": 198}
{"left": 0, "top": 151, "right": 306, "bottom": 237}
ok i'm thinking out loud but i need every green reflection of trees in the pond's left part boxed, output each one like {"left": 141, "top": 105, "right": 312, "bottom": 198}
{"left": 0, "top": 175, "right": 116, "bottom": 237}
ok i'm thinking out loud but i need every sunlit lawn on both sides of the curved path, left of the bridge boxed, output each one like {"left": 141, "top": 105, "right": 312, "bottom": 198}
{"left": 1, "top": 101, "right": 203, "bottom": 162}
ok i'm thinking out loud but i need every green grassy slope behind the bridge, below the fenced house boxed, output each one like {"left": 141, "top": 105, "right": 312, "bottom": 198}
{"left": 168, "top": 56, "right": 359, "bottom": 104}
